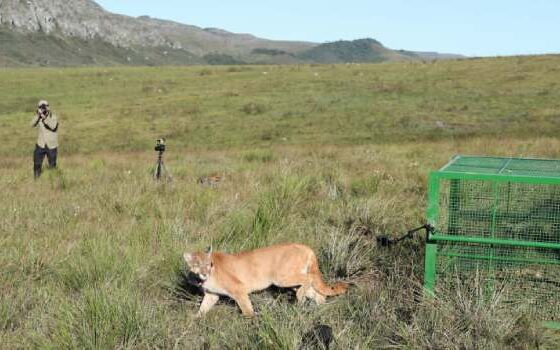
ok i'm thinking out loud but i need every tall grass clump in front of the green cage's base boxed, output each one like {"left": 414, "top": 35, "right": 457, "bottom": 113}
{"left": 394, "top": 277, "right": 560, "bottom": 349}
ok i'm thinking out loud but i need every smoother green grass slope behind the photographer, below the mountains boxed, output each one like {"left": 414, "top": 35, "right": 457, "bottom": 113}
{"left": 0, "top": 56, "right": 560, "bottom": 156}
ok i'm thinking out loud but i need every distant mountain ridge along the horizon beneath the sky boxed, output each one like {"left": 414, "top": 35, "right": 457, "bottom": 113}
{"left": 0, "top": 0, "right": 464, "bottom": 66}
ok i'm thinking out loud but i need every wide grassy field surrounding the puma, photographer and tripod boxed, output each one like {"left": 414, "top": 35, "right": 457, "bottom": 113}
{"left": 0, "top": 56, "right": 560, "bottom": 349}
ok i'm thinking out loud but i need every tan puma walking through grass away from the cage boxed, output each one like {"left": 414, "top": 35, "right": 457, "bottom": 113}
{"left": 184, "top": 244, "right": 348, "bottom": 316}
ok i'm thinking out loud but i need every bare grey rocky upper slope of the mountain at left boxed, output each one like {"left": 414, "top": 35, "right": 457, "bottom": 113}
{"left": 0, "top": 0, "right": 314, "bottom": 56}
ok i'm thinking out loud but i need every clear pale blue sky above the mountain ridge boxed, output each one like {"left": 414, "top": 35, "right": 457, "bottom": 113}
{"left": 96, "top": 0, "right": 560, "bottom": 56}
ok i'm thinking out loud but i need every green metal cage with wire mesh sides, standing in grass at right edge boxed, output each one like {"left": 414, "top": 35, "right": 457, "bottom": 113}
{"left": 424, "top": 156, "right": 560, "bottom": 326}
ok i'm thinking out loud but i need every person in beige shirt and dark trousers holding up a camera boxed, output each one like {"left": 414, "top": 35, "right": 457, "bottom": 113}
{"left": 31, "top": 100, "right": 58, "bottom": 178}
